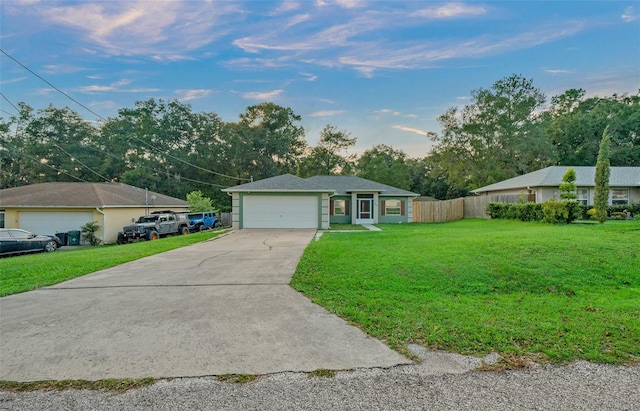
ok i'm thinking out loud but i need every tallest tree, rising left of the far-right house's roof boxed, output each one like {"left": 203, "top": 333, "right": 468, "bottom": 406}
{"left": 431, "top": 75, "right": 553, "bottom": 189}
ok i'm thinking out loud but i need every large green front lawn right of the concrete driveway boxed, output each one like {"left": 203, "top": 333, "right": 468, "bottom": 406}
{"left": 292, "top": 220, "right": 640, "bottom": 363}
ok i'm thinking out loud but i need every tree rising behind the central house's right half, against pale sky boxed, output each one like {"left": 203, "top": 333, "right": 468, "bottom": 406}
{"left": 298, "top": 124, "right": 356, "bottom": 177}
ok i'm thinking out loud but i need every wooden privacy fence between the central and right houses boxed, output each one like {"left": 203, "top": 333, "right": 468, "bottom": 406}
{"left": 413, "top": 195, "right": 536, "bottom": 223}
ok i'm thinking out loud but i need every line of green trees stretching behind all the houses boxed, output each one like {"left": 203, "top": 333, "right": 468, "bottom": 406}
{"left": 0, "top": 75, "right": 640, "bottom": 208}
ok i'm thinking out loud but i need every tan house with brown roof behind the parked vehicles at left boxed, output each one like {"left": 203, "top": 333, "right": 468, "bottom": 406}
{"left": 0, "top": 183, "right": 189, "bottom": 244}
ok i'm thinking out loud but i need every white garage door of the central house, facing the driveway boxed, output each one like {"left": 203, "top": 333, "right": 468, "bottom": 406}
{"left": 242, "top": 195, "right": 318, "bottom": 228}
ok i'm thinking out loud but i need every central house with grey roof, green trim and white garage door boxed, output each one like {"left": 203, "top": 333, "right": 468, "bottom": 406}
{"left": 222, "top": 174, "right": 418, "bottom": 229}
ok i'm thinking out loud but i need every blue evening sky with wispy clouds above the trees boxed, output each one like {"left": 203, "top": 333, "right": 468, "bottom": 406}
{"left": 0, "top": 0, "right": 640, "bottom": 157}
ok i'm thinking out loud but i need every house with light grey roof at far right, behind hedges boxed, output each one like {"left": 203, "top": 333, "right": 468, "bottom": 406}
{"left": 473, "top": 166, "right": 640, "bottom": 205}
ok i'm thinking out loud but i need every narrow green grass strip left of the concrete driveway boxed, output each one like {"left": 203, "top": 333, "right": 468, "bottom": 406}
{"left": 0, "top": 231, "right": 223, "bottom": 297}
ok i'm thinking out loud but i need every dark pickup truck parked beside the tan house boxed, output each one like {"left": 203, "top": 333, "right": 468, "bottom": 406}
{"left": 117, "top": 210, "right": 189, "bottom": 244}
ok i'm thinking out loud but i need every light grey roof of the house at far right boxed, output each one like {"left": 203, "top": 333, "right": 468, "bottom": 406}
{"left": 473, "top": 166, "right": 640, "bottom": 193}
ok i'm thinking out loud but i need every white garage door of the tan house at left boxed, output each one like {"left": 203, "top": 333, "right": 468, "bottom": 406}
{"left": 20, "top": 211, "right": 93, "bottom": 234}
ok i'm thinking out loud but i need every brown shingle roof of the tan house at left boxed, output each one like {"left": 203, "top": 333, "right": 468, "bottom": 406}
{"left": 0, "top": 182, "right": 189, "bottom": 208}
